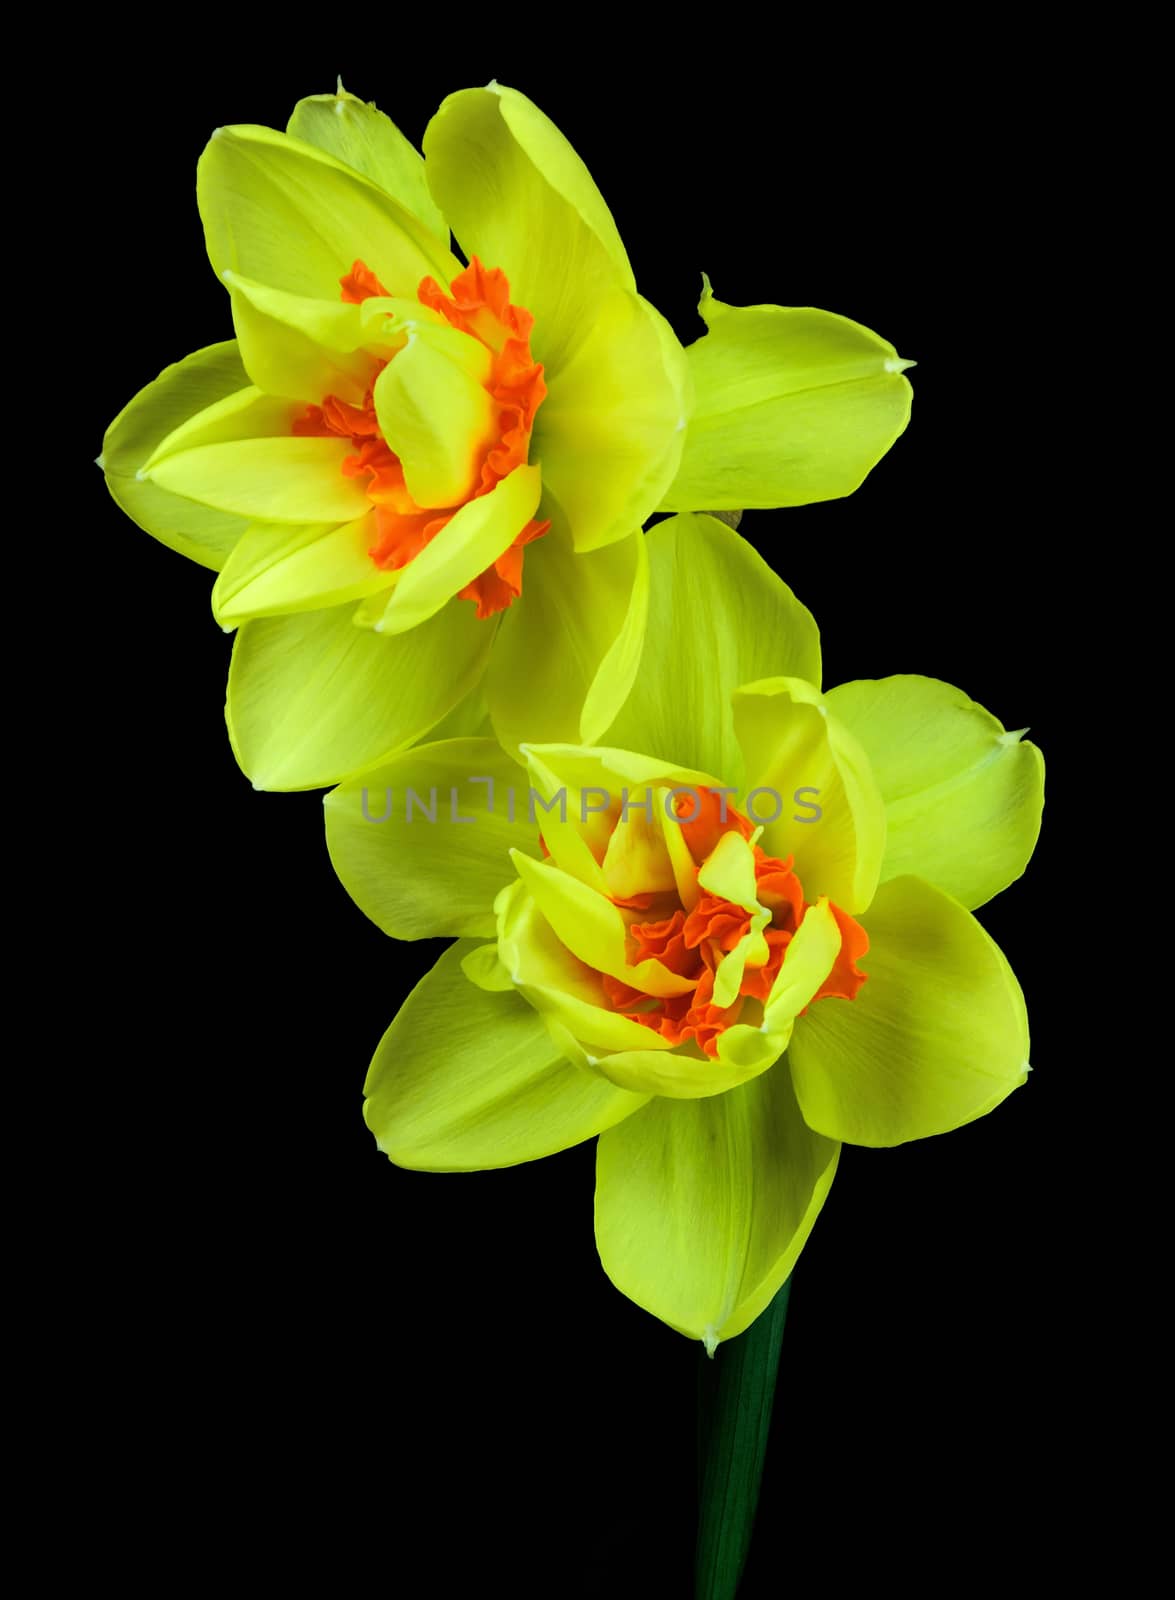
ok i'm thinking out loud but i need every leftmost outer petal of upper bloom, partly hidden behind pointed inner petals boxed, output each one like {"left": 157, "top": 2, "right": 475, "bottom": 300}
{"left": 101, "top": 342, "right": 257, "bottom": 571}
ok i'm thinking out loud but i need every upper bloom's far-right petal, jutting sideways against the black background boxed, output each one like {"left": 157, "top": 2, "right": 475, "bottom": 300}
{"left": 663, "top": 282, "right": 912, "bottom": 510}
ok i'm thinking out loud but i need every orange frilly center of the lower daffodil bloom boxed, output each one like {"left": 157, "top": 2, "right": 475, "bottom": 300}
{"left": 600, "top": 789, "right": 869, "bottom": 1058}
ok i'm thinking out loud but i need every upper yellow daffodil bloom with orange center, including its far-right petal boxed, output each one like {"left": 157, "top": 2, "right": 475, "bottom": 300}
{"left": 101, "top": 85, "right": 909, "bottom": 789}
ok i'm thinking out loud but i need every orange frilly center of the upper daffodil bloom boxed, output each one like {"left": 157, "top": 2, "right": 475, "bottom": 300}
{"left": 293, "top": 256, "right": 551, "bottom": 618}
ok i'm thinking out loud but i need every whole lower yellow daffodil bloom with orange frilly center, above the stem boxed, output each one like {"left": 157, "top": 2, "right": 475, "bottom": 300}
{"left": 327, "top": 515, "right": 1044, "bottom": 1350}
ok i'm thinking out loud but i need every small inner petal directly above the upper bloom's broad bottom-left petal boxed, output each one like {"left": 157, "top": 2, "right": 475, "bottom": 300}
{"left": 213, "top": 512, "right": 392, "bottom": 627}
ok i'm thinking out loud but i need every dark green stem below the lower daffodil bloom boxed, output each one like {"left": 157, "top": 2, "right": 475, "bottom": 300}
{"left": 695, "top": 1278, "right": 791, "bottom": 1600}
